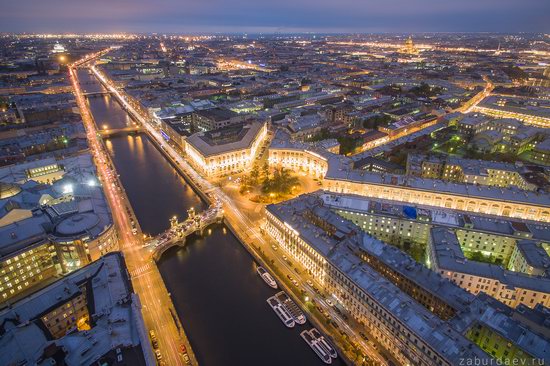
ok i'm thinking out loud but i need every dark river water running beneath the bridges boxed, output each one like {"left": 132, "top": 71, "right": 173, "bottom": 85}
{"left": 79, "top": 70, "right": 343, "bottom": 366}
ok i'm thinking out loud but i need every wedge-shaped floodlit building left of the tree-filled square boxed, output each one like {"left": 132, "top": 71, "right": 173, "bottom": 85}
{"left": 185, "top": 122, "right": 267, "bottom": 177}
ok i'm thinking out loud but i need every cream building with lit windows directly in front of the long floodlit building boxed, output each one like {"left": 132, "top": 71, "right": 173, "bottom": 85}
{"left": 319, "top": 192, "right": 550, "bottom": 264}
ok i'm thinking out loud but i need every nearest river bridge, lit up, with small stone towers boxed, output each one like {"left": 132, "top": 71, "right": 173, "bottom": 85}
{"left": 145, "top": 203, "right": 223, "bottom": 261}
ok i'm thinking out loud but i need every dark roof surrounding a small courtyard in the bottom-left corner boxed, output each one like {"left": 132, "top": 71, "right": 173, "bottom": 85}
{"left": 0, "top": 252, "right": 145, "bottom": 366}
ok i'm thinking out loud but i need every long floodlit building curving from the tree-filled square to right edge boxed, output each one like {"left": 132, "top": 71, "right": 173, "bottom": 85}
{"left": 269, "top": 131, "right": 550, "bottom": 222}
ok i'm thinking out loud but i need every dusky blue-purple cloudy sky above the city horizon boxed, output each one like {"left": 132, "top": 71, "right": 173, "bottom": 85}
{"left": 0, "top": 0, "right": 550, "bottom": 33}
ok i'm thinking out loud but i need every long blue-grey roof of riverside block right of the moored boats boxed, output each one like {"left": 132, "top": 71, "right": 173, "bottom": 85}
{"left": 266, "top": 194, "right": 550, "bottom": 363}
